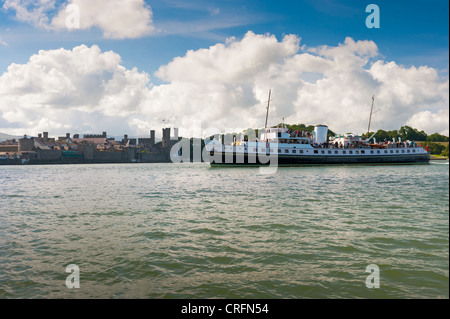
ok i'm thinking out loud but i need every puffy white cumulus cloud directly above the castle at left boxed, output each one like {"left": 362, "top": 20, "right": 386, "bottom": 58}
{"left": 0, "top": 45, "right": 149, "bottom": 134}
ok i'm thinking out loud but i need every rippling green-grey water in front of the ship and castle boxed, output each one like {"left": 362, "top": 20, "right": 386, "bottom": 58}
{"left": 0, "top": 161, "right": 449, "bottom": 299}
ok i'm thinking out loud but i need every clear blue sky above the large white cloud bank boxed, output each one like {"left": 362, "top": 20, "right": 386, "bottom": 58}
{"left": 0, "top": 0, "right": 449, "bottom": 73}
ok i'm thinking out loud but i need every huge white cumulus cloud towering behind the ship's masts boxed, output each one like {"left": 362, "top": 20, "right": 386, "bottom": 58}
{"left": 147, "top": 32, "right": 448, "bottom": 138}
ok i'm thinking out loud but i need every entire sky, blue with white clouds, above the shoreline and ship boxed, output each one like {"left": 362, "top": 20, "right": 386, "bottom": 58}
{"left": 0, "top": 0, "right": 449, "bottom": 136}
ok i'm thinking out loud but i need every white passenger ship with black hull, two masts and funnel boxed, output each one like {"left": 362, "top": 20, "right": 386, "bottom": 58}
{"left": 205, "top": 94, "right": 430, "bottom": 166}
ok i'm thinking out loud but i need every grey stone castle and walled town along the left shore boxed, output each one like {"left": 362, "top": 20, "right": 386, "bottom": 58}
{"left": 0, "top": 128, "right": 179, "bottom": 164}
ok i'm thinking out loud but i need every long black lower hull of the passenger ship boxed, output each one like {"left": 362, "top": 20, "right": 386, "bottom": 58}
{"left": 209, "top": 153, "right": 430, "bottom": 166}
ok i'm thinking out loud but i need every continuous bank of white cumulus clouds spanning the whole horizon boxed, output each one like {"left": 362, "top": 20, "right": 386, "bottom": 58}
{"left": 0, "top": 32, "right": 449, "bottom": 136}
